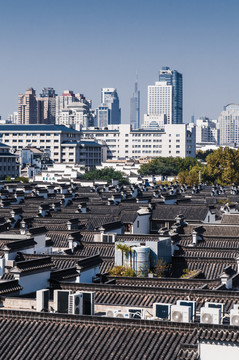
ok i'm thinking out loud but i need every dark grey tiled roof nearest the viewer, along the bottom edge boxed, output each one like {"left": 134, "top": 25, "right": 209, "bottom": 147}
{"left": 0, "top": 310, "right": 239, "bottom": 360}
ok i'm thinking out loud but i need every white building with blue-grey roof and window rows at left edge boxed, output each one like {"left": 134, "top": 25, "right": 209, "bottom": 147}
{"left": 0, "top": 125, "right": 80, "bottom": 162}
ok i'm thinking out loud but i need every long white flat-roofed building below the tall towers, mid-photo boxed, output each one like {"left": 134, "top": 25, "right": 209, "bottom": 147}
{"left": 81, "top": 124, "right": 196, "bottom": 160}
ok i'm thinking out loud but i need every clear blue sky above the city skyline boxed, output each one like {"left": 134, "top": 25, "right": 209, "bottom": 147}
{"left": 0, "top": 0, "right": 239, "bottom": 123}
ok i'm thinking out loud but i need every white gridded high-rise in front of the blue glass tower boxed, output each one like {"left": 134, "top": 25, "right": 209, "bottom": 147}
{"left": 148, "top": 81, "right": 173, "bottom": 124}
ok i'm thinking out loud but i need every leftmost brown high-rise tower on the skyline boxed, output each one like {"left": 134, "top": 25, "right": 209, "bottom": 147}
{"left": 18, "top": 88, "right": 37, "bottom": 124}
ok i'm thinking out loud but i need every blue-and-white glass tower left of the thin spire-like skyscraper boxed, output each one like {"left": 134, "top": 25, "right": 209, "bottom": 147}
{"left": 101, "top": 88, "right": 121, "bottom": 124}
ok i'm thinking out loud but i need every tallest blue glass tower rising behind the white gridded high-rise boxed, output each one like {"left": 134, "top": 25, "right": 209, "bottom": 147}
{"left": 159, "top": 66, "right": 183, "bottom": 124}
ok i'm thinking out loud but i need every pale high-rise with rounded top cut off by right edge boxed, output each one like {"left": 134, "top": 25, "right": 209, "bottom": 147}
{"left": 218, "top": 104, "right": 239, "bottom": 147}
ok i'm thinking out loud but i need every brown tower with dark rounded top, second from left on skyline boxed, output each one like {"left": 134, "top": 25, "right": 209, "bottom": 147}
{"left": 37, "top": 87, "right": 57, "bottom": 124}
